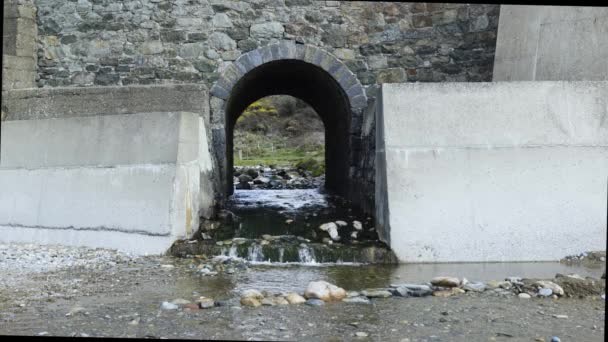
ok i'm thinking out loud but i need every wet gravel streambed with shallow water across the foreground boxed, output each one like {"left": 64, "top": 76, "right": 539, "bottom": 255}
{"left": 0, "top": 244, "right": 605, "bottom": 341}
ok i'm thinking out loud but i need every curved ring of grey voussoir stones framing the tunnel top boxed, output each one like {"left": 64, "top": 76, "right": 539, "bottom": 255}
{"left": 210, "top": 41, "right": 367, "bottom": 112}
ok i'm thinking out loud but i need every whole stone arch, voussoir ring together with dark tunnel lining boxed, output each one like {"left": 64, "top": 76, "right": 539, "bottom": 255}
{"left": 210, "top": 41, "right": 367, "bottom": 198}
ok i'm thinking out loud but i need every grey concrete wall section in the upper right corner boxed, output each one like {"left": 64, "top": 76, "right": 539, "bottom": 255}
{"left": 493, "top": 5, "right": 608, "bottom": 81}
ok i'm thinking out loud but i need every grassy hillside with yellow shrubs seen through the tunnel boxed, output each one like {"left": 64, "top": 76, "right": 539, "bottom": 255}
{"left": 234, "top": 96, "right": 325, "bottom": 168}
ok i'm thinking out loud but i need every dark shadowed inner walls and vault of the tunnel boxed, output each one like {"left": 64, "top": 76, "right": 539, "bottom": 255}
{"left": 225, "top": 60, "right": 351, "bottom": 196}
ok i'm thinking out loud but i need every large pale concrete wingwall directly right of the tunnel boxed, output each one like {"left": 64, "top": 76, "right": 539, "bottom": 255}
{"left": 376, "top": 81, "right": 608, "bottom": 262}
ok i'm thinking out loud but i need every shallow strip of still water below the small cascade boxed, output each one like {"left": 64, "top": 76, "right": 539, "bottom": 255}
{"left": 184, "top": 262, "right": 604, "bottom": 298}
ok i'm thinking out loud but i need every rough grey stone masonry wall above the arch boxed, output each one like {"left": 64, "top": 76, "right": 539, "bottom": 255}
{"left": 34, "top": 0, "right": 499, "bottom": 92}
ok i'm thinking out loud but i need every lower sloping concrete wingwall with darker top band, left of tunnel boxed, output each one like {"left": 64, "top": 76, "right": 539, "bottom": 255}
{"left": 0, "top": 85, "right": 213, "bottom": 254}
